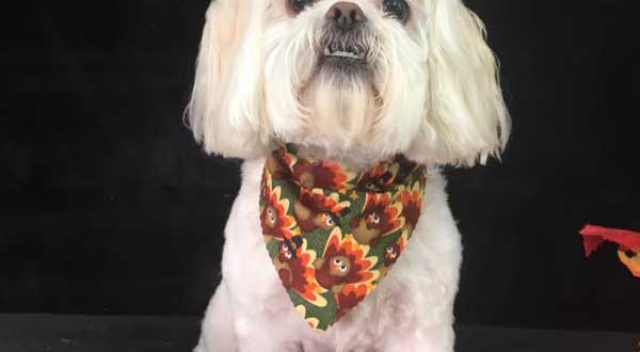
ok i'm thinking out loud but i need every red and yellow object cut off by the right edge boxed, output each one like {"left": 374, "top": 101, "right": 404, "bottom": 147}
{"left": 580, "top": 225, "right": 640, "bottom": 277}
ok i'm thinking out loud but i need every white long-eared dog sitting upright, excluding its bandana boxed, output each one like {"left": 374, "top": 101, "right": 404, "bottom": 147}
{"left": 187, "top": 0, "right": 510, "bottom": 352}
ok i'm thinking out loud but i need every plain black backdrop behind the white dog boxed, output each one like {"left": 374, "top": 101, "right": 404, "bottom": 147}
{"left": 0, "top": 0, "right": 640, "bottom": 331}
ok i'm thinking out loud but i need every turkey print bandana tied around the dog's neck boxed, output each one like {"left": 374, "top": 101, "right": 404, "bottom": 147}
{"left": 260, "top": 146, "right": 426, "bottom": 331}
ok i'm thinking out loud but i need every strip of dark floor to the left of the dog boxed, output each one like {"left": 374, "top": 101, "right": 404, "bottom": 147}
{"left": 0, "top": 315, "right": 200, "bottom": 352}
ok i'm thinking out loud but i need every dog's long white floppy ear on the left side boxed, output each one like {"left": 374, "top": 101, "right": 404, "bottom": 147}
{"left": 186, "top": 0, "right": 269, "bottom": 159}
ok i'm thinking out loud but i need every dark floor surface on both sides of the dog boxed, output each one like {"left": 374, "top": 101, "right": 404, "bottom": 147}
{"left": 0, "top": 315, "right": 640, "bottom": 352}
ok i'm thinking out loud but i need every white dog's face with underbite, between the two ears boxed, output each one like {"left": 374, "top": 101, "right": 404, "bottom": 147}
{"left": 264, "top": 0, "right": 427, "bottom": 162}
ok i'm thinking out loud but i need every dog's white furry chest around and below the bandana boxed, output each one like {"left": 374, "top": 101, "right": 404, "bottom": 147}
{"left": 223, "top": 161, "right": 458, "bottom": 351}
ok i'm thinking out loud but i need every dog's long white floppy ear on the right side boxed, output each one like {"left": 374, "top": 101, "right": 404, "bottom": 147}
{"left": 410, "top": 0, "right": 510, "bottom": 166}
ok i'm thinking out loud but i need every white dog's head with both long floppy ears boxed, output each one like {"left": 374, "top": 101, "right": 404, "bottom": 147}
{"left": 188, "top": 0, "right": 510, "bottom": 165}
